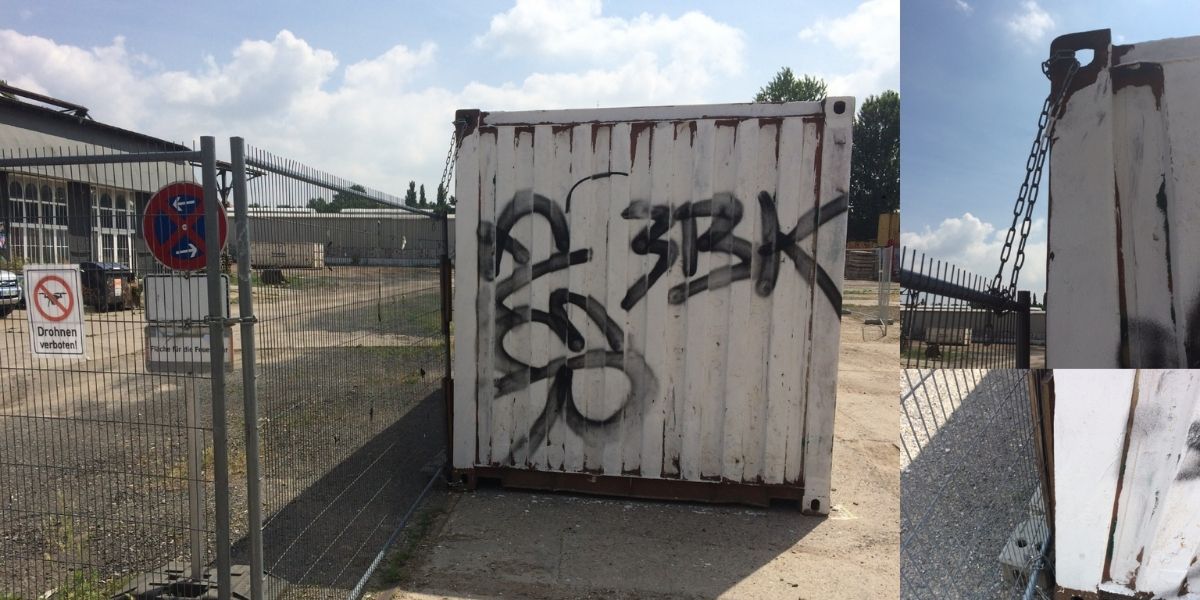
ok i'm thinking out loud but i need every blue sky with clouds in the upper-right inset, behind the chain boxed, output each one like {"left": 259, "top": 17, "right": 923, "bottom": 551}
{"left": 900, "top": 0, "right": 1200, "bottom": 293}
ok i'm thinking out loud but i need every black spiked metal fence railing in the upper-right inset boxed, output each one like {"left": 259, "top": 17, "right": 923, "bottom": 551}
{"left": 900, "top": 248, "right": 1032, "bottom": 368}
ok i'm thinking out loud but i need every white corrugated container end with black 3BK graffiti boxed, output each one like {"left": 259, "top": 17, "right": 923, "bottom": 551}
{"left": 454, "top": 98, "right": 854, "bottom": 512}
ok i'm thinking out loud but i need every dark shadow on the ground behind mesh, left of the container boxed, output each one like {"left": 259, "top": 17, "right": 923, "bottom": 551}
{"left": 233, "top": 391, "right": 445, "bottom": 598}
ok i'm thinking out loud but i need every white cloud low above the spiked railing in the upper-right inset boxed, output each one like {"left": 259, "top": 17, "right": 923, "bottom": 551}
{"left": 900, "top": 212, "right": 1046, "bottom": 295}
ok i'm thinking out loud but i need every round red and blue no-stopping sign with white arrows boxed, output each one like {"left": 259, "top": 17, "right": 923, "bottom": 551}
{"left": 142, "top": 181, "right": 228, "bottom": 271}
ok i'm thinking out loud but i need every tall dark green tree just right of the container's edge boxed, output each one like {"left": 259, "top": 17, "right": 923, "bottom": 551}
{"left": 846, "top": 90, "right": 900, "bottom": 241}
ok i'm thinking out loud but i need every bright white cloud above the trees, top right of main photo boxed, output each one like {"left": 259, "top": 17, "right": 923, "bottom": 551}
{"left": 799, "top": 0, "right": 900, "bottom": 97}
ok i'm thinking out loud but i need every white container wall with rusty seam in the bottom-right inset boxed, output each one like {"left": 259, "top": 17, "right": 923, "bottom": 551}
{"left": 1054, "top": 370, "right": 1200, "bottom": 599}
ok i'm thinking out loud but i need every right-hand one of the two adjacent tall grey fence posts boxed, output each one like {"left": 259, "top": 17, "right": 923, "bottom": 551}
{"left": 229, "top": 138, "right": 263, "bottom": 600}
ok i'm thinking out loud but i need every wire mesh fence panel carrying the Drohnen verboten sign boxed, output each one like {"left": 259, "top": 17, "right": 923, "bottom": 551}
{"left": 0, "top": 143, "right": 224, "bottom": 599}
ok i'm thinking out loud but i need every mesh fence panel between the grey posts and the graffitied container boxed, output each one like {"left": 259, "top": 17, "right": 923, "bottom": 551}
{"left": 238, "top": 148, "right": 446, "bottom": 598}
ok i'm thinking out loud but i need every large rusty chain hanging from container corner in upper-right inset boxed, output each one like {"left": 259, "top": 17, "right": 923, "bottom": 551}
{"left": 991, "top": 50, "right": 1079, "bottom": 299}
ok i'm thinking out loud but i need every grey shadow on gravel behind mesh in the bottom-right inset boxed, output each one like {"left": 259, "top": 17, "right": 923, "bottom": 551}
{"left": 900, "top": 371, "right": 1037, "bottom": 599}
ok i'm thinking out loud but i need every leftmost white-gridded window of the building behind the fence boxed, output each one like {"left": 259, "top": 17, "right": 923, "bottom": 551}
{"left": 8, "top": 175, "right": 71, "bottom": 263}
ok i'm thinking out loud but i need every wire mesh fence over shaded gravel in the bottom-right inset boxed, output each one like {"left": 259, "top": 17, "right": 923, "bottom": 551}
{"left": 900, "top": 370, "right": 1052, "bottom": 600}
